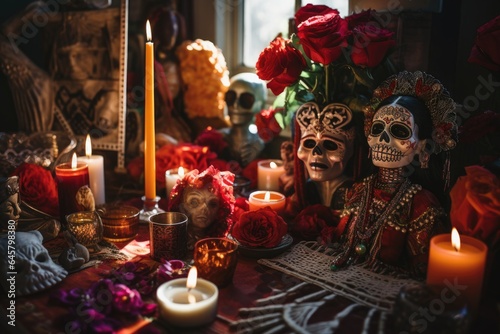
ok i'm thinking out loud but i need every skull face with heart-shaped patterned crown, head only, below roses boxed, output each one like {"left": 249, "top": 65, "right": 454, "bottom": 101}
{"left": 296, "top": 102, "right": 355, "bottom": 182}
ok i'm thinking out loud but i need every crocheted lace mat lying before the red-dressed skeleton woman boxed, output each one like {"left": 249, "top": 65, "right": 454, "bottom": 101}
{"left": 258, "top": 241, "right": 420, "bottom": 311}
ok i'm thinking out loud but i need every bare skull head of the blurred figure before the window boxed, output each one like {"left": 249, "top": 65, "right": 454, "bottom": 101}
{"left": 225, "top": 73, "right": 267, "bottom": 125}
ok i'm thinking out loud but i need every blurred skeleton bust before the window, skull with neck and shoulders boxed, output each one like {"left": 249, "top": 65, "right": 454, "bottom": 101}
{"left": 223, "top": 73, "right": 267, "bottom": 165}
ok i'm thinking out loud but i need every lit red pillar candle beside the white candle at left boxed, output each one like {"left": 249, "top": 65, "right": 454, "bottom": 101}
{"left": 56, "top": 153, "right": 89, "bottom": 224}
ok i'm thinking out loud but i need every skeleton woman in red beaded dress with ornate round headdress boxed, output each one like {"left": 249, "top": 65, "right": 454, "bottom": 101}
{"left": 331, "top": 72, "right": 456, "bottom": 278}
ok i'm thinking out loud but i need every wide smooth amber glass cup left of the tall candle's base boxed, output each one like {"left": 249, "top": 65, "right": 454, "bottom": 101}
{"left": 97, "top": 204, "right": 140, "bottom": 242}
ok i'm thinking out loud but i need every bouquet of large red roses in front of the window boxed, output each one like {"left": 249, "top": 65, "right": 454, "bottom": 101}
{"left": 256, "top": 4, "right": 396, "bottom": 126}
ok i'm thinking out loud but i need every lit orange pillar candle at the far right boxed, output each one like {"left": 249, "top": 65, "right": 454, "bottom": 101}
{"left": 427, "top": 228, "right": 488, "bottom": 313}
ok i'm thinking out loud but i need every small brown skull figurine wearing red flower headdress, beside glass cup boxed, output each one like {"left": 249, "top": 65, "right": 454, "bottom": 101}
{"left": 168, "top": 166, "right": 235, "bottom": 249}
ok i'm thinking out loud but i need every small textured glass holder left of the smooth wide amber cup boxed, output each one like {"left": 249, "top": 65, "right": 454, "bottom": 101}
{"left": 66, "top": 211, "right": 102, "bottom": 247}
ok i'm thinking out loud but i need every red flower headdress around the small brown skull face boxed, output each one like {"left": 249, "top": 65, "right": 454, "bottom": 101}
{"left": 168, "top": 165, "right": 235, "bottom": 237}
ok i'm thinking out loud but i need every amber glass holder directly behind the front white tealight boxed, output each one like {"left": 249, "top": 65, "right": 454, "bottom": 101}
{"left": 193, "top": 238, "right": 238, "bottom": 287}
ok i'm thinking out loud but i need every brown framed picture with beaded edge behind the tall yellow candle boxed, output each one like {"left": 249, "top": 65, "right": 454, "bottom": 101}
{"left": 45, "top": 0, "right": 128, "bottom": 169}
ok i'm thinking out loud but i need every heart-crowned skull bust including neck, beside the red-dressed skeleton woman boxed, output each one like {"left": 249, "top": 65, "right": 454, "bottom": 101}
{"left": 295, "top": 102, "right": 355, "bottom": 211}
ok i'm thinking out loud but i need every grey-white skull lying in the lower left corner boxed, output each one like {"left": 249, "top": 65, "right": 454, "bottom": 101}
{"left": 0, "top": 230, "right": 68, "bottom": 296}
